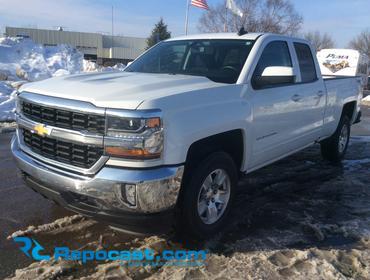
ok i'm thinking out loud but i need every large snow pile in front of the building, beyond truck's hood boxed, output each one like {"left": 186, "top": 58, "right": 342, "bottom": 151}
{"left": 0, "top": 37, "right": 125, "bottom": 121}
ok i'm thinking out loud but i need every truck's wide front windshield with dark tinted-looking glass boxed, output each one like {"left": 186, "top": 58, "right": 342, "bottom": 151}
{"left": 125, "top": 40, "right": 254, "bottom": 84}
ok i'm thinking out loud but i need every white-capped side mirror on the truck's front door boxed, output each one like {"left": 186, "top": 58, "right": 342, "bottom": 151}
{"left": 252, "top": 66, "right": 296, "bottom": 89}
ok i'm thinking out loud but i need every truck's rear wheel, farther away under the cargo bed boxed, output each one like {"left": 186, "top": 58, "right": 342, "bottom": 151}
{"left": 320, "top": 115, "right": 351, "bottom": 163}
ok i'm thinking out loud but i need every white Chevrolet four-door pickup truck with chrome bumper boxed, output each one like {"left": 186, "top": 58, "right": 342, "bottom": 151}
{"left": 12, "top": 33, "right": 361, "bottom": 238}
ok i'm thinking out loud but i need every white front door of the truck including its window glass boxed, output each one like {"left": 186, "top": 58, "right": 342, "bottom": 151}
{"left": 250, "top": 38, "right": 307, "bottom": 168}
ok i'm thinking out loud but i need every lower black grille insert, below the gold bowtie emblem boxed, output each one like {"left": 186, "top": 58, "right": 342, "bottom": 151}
{"left": 21, "top": 129, "right": 104, "bottom": 169}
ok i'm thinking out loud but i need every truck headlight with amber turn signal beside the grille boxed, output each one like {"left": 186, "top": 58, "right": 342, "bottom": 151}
{"left": 104, "top": 116, "right": 163, "bottom": 160}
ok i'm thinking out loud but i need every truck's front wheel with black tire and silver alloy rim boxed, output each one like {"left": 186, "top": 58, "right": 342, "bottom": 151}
{"left": 176, "top": 152, "right": 238, "bottom": 239}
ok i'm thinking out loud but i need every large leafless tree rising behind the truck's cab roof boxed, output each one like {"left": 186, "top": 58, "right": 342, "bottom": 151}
{"left": 198, "top": 0, "right": 303, "bottom": 35}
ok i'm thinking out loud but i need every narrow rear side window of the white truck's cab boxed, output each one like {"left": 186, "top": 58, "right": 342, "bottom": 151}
{"left": 294, "top": 43, "right": 317, "bottom": 83}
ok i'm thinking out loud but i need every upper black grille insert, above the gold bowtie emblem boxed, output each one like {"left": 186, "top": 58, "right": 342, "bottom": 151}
{"left": 20, "top": 100, "right": 105, "bottom": 135}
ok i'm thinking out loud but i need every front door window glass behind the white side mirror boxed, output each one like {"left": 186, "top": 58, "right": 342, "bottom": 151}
{"left": 252, "top": 41, "right": 294, "bottom": 88}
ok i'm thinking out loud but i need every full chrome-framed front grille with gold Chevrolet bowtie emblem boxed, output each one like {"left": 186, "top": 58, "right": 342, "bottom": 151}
{"left": 16, "top": 92, "right": 108, "bottom": 172}
